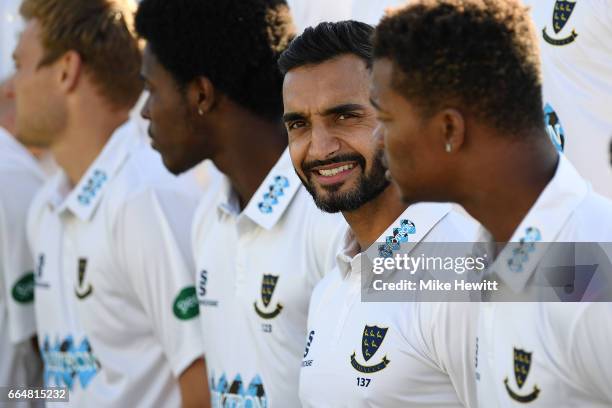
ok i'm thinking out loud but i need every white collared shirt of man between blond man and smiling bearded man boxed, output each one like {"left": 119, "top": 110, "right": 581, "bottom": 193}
{"left": 193, "top": 150, "right": 346, "bottom": 408}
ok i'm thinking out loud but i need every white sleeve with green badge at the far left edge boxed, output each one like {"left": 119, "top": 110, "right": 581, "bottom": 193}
{"left": 0, "top": 171, "right": 42, "bottom": 343}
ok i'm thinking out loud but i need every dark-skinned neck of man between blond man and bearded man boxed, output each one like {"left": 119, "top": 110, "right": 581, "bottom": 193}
{"left": 214, "top": 114, "right": 287, "bottom": 209}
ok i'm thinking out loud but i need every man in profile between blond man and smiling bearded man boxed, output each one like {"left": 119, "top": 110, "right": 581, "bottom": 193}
{"left": 136, "top": 0, "right": 346, "bottom": 407}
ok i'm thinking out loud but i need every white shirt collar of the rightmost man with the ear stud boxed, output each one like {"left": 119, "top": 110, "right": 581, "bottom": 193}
{"left": 480, "top": 155, "right": 591, "bottom": 293}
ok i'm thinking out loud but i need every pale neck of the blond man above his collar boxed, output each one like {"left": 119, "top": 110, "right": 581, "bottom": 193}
{"left": 51, "top": 111, "right": 128, "bottom": 187}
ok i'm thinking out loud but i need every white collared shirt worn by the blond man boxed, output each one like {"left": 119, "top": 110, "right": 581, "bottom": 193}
{"left": 28, "top": 122, "right": 202, "bottom": 407}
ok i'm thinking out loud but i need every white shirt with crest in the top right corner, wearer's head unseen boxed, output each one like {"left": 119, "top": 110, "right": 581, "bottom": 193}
{"left": 525, "top": 0, "right": 612, "bottom": 198}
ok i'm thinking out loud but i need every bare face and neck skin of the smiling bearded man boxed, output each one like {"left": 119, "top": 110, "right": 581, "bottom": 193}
{"left": 283, "top": 55, "right": 406, "bottom": 248}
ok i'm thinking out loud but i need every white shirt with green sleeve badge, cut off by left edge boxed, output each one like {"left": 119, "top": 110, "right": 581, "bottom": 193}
{"left": 0, "top": 128, "right": 44, "bottom": 387}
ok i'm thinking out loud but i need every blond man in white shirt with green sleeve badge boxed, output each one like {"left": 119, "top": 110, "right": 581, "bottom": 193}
{"left": 14, "top": 0, "right": 207, "bottom": 407}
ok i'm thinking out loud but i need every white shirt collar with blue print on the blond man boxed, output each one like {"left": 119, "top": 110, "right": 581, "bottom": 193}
{"left": 50, "top": 121, "right": 142, "bottom": 221}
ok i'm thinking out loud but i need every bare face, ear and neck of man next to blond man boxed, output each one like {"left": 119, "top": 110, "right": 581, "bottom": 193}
{"left": 141, "top": 47, "right": 286, "bottom": 208}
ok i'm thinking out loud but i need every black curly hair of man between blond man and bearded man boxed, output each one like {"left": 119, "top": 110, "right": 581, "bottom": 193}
{"left": 136, "top": 0, "right": 294, "bottom": 120}
